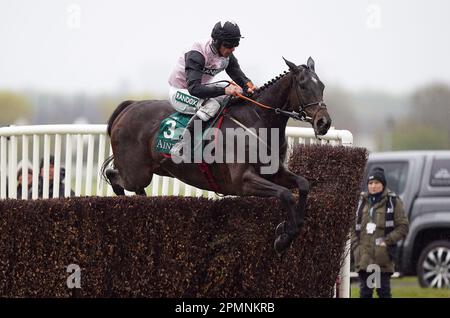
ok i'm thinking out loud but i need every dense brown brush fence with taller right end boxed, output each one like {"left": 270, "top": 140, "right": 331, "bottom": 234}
{"left": 0, "top": 146, "right": 367, "bottom": 297}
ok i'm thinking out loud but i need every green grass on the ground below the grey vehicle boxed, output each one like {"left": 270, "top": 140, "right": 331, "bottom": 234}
{"left": 351, "top": 277, "right": 450, "bottom": 298}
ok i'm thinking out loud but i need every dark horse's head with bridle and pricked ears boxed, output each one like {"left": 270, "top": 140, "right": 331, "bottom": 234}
{"left": 283, "top": 57, "right": 331, "bottom": 135}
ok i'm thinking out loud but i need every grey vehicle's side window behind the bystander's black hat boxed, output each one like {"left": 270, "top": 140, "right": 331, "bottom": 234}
{"left": 364, "top": 161, "right": 409, "bottom": 195}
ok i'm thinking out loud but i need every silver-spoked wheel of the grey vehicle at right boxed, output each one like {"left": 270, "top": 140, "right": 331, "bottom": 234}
{"left": 417, "top": 241, "right": 450, "bottom": 288}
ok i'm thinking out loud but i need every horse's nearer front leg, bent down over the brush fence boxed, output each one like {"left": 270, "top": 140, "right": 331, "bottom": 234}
{"left": 242, "top": 168, "right": 300, "bottom": 254}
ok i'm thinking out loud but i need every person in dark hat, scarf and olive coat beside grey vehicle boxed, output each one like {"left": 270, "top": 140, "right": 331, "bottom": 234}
{"left": 352, "top": 167, "right": 409, "bottom": 298}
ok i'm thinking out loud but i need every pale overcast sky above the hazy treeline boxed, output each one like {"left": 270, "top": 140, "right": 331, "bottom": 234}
{"left": 0, "top": 0, "right": 450, "bottom": 96}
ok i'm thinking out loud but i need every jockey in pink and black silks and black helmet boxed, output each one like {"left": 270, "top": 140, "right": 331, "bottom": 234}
{"left": 169, "top": 21, "right": 256, "bottom": 156}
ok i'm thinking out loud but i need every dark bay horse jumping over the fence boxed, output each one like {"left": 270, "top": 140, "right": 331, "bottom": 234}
{"left": 102, "top": 58, "right": 331, "bottom": 254}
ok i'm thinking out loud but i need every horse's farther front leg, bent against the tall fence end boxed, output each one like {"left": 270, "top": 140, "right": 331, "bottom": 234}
{"left": 273, "top": 165, "right": 309, "bottom": 234}
